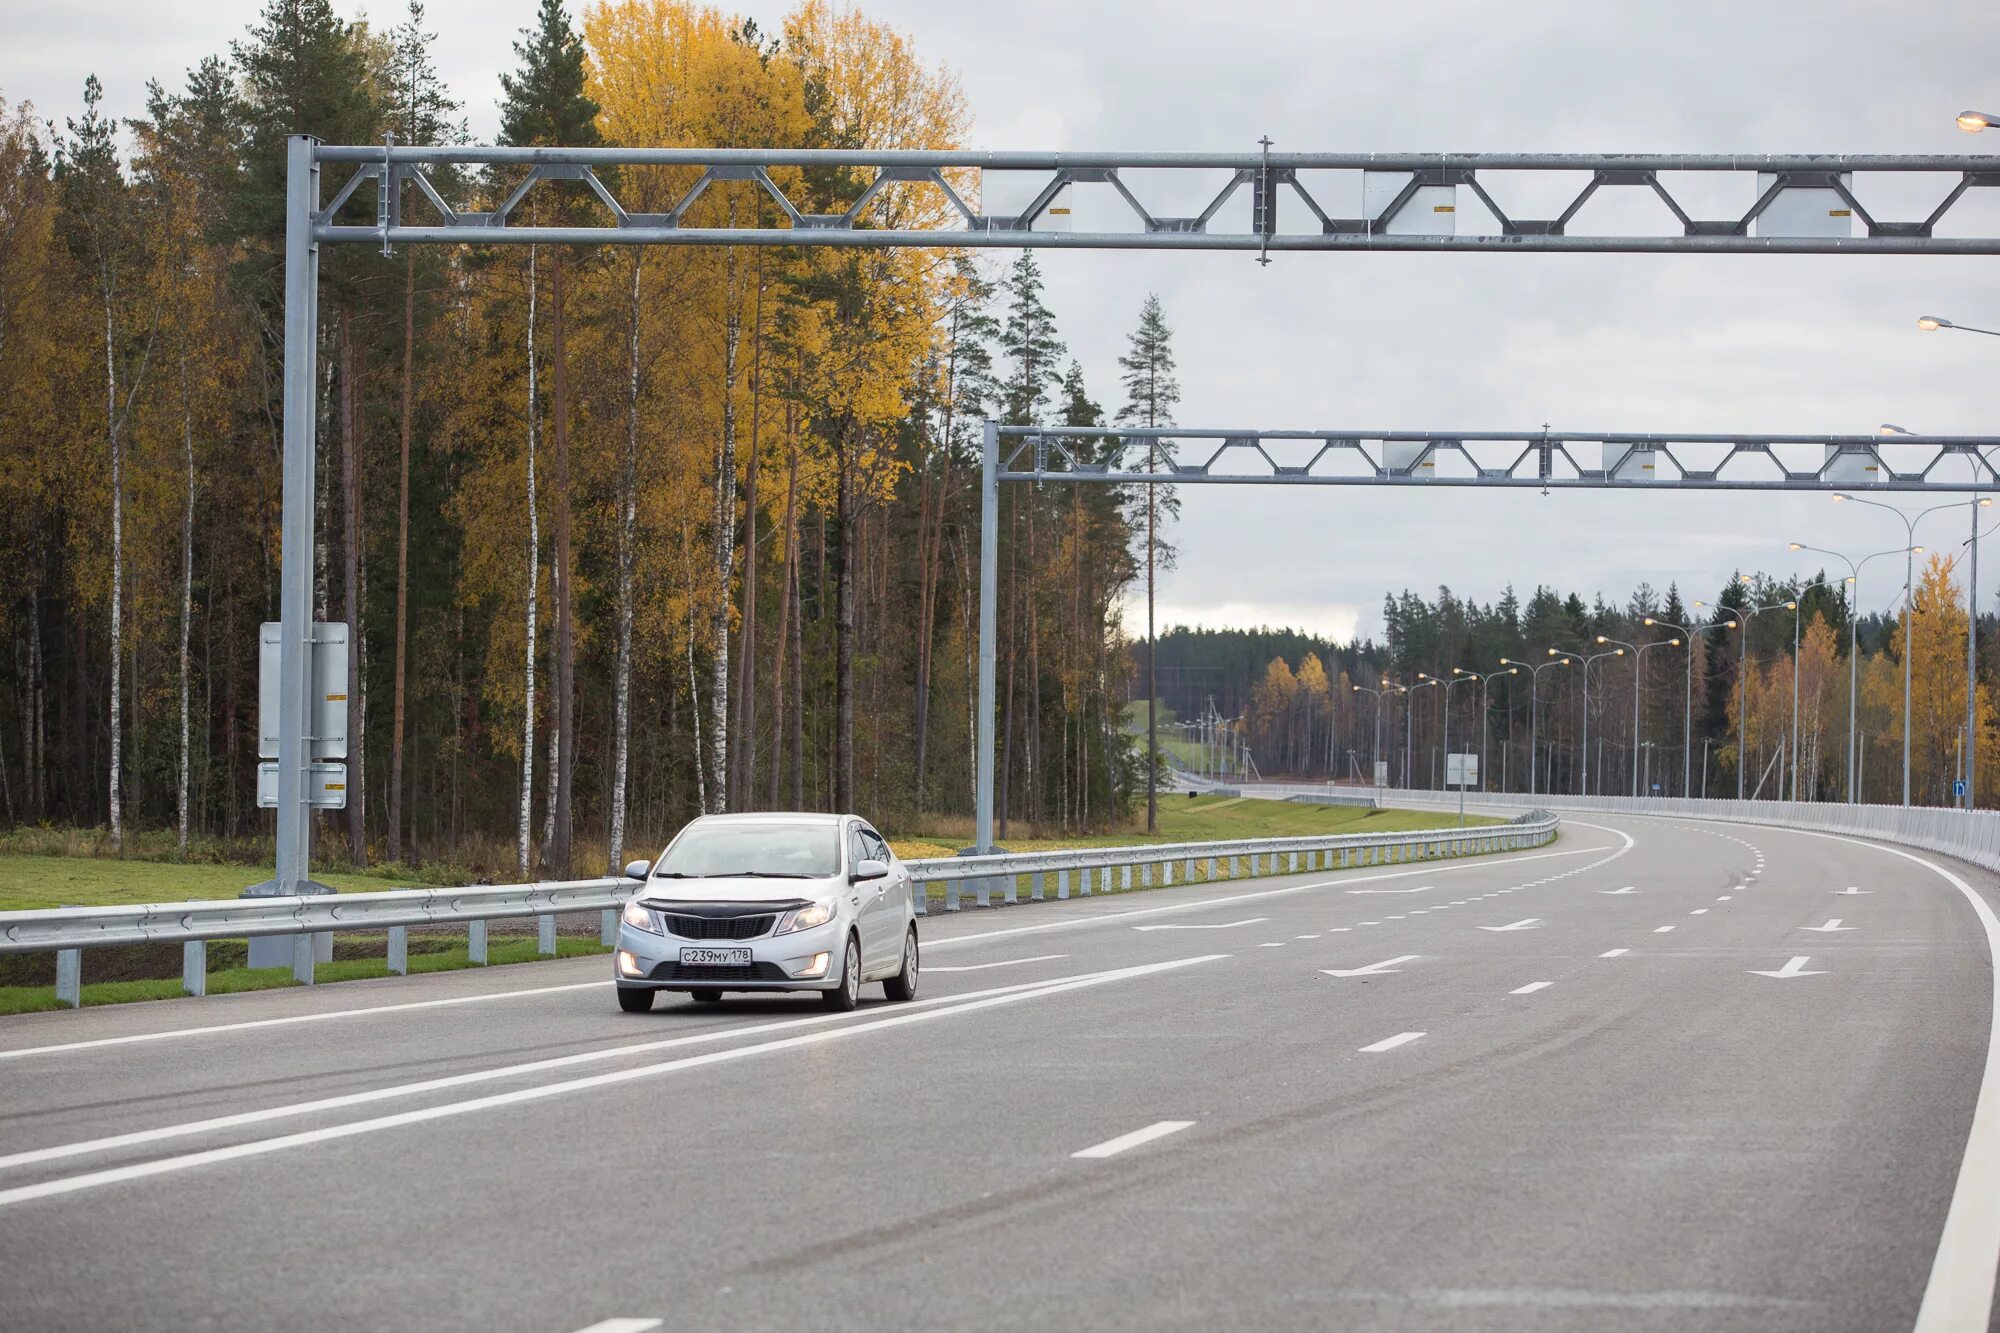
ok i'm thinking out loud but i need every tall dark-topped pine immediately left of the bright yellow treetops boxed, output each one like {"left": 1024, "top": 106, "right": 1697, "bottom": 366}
{"left": 500, "top": 0, "right": 600, "bottom": 875}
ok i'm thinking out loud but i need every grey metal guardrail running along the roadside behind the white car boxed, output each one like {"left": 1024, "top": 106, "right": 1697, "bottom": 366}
{"left": 0, "top": 811, "right": 1556, "bottom": 1009}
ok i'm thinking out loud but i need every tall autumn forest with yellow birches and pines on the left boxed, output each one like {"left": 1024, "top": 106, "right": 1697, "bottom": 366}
{"left": 0, "top": 0, "right": 1176, "bottom": 877}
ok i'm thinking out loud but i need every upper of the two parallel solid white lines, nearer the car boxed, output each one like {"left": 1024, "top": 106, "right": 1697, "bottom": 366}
{"left": 0, "top": 967, "right": 1144, "bottom": 1169}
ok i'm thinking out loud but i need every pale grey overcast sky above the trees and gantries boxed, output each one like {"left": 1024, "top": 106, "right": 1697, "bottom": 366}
{"left": 0, "top": 0, "right": 2000, "bottom": 636}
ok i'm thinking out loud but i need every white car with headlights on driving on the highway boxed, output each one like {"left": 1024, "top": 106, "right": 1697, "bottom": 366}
{"left": 612, "top": 815, "right": 918, "bottom": 1013}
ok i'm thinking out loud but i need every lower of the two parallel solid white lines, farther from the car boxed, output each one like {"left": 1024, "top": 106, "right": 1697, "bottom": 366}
{"left": 0, "top": 953, "right": 1230, "bottom": 1207}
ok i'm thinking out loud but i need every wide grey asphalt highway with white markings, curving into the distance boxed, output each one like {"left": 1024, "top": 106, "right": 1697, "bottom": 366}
{"left": 0, "top": 815, "right": 2000, "bottom": 1333}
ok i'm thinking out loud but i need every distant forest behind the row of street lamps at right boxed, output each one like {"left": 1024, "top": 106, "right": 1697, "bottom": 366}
{"left": 1168, "top": 554, "right": 2000, "bottom": 807}
